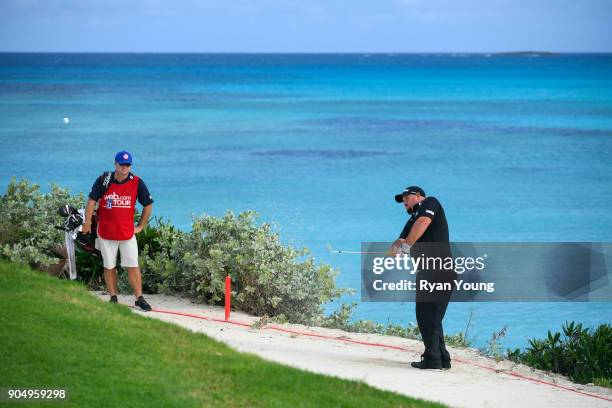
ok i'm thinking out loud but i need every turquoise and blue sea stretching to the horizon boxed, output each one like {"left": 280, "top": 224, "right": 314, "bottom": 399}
{"left": 0, "top": 54, "right": 612, "bottom": 347}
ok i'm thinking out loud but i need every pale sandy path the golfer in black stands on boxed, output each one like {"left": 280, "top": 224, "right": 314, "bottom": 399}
{"left": 96, "top": 292, "right": 612, "bottom": 408}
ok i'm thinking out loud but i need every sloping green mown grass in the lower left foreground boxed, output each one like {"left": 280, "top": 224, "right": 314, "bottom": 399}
{"left": 0, "top": 260, "right": 443, "bottom": 407}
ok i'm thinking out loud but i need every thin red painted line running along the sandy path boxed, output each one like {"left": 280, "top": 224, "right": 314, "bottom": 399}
{"left": 143, "top": 306, "right": 612, "bottom": 402}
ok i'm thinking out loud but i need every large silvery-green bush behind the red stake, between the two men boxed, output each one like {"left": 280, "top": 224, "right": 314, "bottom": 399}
{"left": 142, "top": 211, "right": 345, "bottom": 323}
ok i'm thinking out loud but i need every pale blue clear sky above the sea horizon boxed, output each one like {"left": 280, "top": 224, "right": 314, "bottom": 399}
{"left": 0, "top": 0, "right": 612, "bottom": 53}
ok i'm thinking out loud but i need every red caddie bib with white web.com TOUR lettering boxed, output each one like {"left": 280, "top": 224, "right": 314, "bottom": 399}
{"left": 98, "top": 175, "right": 139, "bottom": 241}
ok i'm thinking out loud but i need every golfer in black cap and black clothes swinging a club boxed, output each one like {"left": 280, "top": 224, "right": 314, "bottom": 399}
{"left": 389, "top": 186, "right": 454, "bottom": 369}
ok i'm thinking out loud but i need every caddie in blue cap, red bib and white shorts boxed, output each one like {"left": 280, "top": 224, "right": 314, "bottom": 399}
{"left": 82, "top": 151, "right": 153, "bottom": 311}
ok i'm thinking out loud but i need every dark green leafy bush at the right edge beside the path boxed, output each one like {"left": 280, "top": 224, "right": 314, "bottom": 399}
{"left": 508, "top": 322, "right": 612, "bottom": 384}
